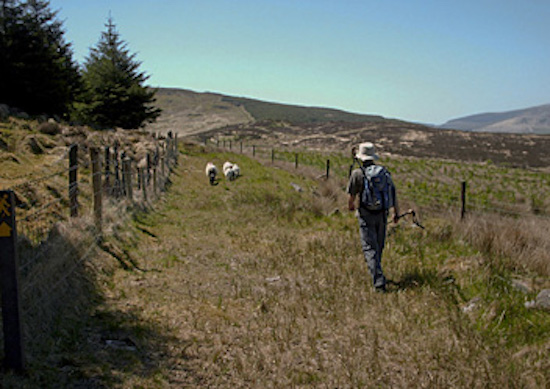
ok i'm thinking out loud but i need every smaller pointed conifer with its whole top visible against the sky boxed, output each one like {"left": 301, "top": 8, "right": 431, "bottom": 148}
{"left": 76, "top": 17, "right": 160, "bottom": 129}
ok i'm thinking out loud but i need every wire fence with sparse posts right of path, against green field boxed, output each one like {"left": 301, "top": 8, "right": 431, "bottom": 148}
{"left": 208, "top": 138, "right": 550, "bottom": 219}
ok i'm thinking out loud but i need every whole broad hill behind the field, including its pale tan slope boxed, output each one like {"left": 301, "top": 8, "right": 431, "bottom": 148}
{"left": 149, "top": 89, "right": 550, "bottom": 168}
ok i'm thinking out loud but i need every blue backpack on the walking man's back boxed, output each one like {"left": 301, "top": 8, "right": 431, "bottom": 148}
{"left": 360, "top": 165, "right": 394, "bottom": 211}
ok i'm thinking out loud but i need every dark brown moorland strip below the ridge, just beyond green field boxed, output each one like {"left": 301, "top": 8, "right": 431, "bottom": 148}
{"left": 199, "top": 120, "right": 550, "bottom": 168}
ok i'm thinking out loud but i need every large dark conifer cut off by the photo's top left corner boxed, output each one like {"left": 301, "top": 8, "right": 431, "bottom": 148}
{"left": 0, "top": 0, "right": 80, "bottom": 115}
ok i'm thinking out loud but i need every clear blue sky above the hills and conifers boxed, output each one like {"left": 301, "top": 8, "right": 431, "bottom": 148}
{"left": 50, "top": 0, "right": 550, "bottom": 124}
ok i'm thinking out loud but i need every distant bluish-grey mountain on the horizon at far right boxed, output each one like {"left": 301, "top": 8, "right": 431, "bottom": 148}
{"left": 439, "top": 104, "right": 550, "bottom": 134}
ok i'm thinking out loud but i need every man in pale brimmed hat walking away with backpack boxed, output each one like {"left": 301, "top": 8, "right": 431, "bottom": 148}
{"left": 347, "top": 142, "right": 399, "bottom": 292}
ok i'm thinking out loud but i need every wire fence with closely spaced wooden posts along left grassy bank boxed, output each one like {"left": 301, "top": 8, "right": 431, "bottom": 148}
{"left": 0, "top": 132, "right": 178, "bottom": 370}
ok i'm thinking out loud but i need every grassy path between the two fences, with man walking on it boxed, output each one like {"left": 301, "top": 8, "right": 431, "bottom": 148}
{"left": 34, "top": 144, "right": 548, "bottom": 388}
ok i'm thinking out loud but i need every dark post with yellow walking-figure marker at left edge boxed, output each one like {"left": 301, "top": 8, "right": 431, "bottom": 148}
{"left": 0, "top": 190, "right": 25, "bottom": 372}
